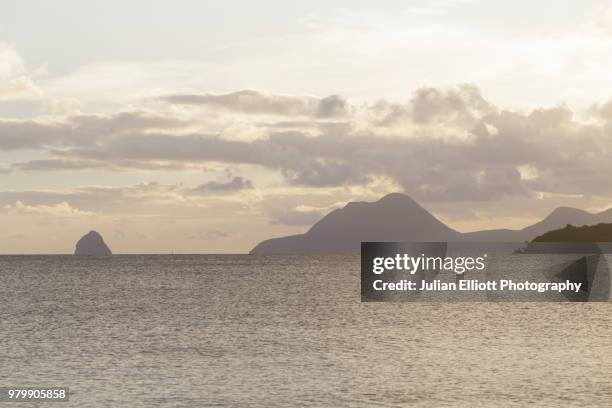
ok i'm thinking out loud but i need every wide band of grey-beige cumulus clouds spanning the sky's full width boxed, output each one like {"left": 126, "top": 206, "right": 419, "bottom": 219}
{"left": 5, "top": 85, "right": 612, "bottom": 207}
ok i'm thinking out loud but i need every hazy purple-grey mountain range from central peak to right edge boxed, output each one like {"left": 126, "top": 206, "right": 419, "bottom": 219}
{"left": 251, "top": 193, "right": 612, "bottom": 254}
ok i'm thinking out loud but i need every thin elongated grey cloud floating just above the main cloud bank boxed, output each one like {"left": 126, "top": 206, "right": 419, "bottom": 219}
{"left": 161, "top": 90, "right": 347, "bottom": 118}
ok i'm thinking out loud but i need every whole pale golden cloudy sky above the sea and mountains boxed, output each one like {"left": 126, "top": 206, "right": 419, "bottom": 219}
{"left": 0, "top": 0, "right": 612, "bottom": 254}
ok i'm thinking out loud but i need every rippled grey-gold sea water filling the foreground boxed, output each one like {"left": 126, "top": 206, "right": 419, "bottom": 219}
{"left": 0, "top": 256, "right": 612, "bottom": 407}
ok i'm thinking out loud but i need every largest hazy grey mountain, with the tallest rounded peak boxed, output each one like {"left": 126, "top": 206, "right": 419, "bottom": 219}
{"left": 251, "top": 193, "right": 461, "bottom": 254}
